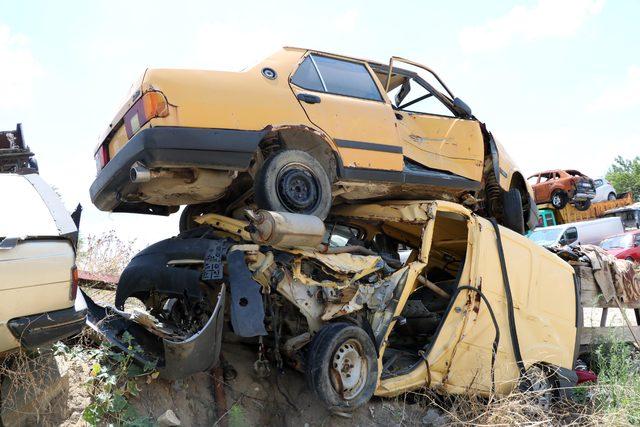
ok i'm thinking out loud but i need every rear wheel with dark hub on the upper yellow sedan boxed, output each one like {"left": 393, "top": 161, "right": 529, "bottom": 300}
{"left": 254, "top": 150, "right": 331, "bottom": 219}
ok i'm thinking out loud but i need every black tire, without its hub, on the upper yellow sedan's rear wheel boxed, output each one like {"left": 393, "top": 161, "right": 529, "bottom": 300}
{"left": 254, "top": 150, "right": 331, "bottom": 219}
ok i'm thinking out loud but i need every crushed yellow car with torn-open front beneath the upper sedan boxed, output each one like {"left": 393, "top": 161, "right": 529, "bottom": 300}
{"left": 82, "top": 201, "right": 581, "bottom": 411}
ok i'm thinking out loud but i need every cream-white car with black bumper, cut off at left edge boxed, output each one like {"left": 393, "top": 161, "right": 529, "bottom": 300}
{"left": 0, "top": 173, "right": 86, "bottom": 356}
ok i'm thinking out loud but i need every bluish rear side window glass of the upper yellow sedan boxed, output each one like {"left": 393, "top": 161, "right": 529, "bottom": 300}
{"left": 291, "top": 55, "right": 382, "bottom": 101}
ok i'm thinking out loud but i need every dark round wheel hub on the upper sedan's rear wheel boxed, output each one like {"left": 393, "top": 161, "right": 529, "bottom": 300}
{"left": 277, "top": 164, "right": 320, "bottom": 213}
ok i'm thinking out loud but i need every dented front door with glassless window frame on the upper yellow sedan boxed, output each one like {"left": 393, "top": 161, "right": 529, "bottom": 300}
{"left": 389, "top": 73, "right": 484, "bottom": 181}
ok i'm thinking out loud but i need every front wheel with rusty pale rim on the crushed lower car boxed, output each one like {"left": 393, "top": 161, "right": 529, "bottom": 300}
{"left": 306, "top": 323, "right": 378, "bottom": 412}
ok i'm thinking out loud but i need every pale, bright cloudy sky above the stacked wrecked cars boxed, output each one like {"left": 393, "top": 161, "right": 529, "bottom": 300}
{"left": 0, "top": 0, "right": 640, "bottom": 247}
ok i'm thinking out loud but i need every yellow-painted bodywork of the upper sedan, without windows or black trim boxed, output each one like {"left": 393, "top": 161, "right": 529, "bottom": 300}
{"left": 103, "top": 48, "right": 530, "bottom": 190}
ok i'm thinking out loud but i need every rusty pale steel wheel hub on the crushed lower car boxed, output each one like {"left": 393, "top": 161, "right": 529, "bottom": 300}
{"left": 331, "top": 340, "right": 367, "bottom": 399}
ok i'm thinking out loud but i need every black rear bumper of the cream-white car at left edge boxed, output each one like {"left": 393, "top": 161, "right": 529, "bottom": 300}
{"left": 7, "top": 292, "right": 87, "bottom": 350}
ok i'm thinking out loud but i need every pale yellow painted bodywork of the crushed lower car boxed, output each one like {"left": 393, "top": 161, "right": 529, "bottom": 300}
{"left": 332, "top": 201, "right": 577, "bottom": 396}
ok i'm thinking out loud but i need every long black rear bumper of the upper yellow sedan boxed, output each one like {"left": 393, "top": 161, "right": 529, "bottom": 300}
{"left": 89, "top": 126, "right": 267, "bottom": 215}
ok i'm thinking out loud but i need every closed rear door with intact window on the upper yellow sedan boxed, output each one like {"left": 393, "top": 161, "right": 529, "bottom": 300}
{"left": 290, "top": 53, "right": 404, "bottom": 171}
